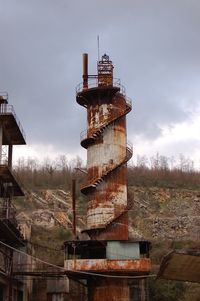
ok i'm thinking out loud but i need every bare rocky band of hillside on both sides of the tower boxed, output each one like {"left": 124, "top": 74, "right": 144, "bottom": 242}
{"left": 15, "top": 186, "right": 200, "bottom": 241}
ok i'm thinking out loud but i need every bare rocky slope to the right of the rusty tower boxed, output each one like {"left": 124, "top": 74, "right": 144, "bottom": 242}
{"left": 129, "top": 187, "right": 200, "bottom": 241}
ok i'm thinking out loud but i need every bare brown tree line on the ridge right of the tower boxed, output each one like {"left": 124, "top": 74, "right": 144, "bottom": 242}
{"left": 128, "top": 153, "right": 200, "bottom": 189}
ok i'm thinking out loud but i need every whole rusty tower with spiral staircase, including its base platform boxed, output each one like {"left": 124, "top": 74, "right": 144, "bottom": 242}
{"left": 65, "top": 54, "right": 150, "bottom": 301}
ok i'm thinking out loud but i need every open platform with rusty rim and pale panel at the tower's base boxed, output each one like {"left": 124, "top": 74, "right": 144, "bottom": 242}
{"left": 64, "top": 240, "right": 151, "bottom": 278}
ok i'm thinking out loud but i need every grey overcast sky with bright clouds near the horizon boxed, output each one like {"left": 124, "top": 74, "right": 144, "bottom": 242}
{"left": 0, "top": 0, "right": 200, "bottom": 164}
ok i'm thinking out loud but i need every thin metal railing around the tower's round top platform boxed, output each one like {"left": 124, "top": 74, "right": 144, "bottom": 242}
{"left": 76, "top": 76, "right": 126, "bottom": 96}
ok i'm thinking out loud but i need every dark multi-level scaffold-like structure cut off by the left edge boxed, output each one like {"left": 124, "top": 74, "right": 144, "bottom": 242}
{"left": 0, "top": 93, "right": 26, "bottom": 301}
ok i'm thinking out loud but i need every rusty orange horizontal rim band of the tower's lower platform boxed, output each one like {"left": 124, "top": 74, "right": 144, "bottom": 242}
{"left": 65, "top": 258, "right": 151, "bottom": 274}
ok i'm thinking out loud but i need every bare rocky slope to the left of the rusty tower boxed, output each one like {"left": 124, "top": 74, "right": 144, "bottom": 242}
{"left": 14, "top": 189, "right": 85, "bottom": 239}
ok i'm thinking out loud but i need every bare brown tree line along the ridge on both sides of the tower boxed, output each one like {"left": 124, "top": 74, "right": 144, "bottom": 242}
{"left": 14, "top": 154, "right": 200, "bottom": 190}
